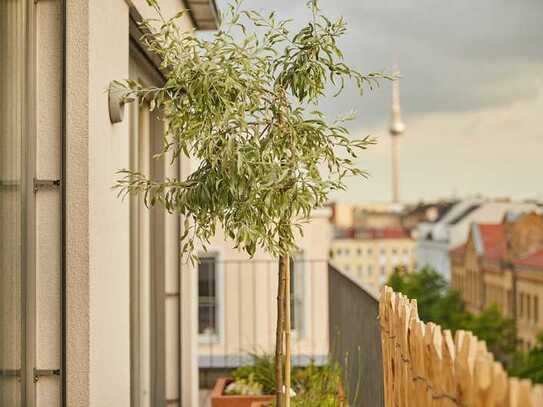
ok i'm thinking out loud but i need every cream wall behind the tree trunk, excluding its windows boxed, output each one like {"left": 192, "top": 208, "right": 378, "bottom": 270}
{"left": 195, "top": 209, "right": 332, "bottom": 367}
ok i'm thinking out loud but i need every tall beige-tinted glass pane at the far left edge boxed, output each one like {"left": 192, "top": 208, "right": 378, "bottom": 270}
{"left": 0, "top": 0, "right": 25, "bottom": 406}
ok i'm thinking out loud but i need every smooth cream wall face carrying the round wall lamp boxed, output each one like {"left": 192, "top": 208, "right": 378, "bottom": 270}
{"left": 88, "top": 0, "right": 130, "bottom": 406}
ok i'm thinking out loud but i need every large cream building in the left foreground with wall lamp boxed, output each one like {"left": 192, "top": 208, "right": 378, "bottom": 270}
{"left": 0, "top": 0, "right": 217, "bottom": 407}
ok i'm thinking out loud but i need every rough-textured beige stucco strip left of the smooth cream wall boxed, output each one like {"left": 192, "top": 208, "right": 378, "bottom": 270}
{"left": 65, "top": 0, "right": 90, "bottom": 406}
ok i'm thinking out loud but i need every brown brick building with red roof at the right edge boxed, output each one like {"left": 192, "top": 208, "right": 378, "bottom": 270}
{"left": 450, "top": 212, "right": 543, "bottom": 348}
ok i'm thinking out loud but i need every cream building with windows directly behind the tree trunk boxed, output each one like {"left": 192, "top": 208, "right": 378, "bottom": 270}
{"left": 198, "top": 209, "right": 332, "bottom": 372}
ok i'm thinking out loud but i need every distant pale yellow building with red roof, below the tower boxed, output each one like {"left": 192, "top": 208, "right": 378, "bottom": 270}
{"left": 330, "top": 228, "right": 416, "bottom": 294}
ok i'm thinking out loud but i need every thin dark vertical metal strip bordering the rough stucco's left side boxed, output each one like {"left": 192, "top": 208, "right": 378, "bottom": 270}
{"left": 60, "top": 0, "right": 67, "bottom": 407}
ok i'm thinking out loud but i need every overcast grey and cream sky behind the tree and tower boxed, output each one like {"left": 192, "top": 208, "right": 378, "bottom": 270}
{"left": 215, "top": 0, "right": 543, "bottom": 202}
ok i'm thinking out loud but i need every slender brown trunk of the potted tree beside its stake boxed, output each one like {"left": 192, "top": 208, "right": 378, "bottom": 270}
{"left": 275, "top": 256, "right": 288, "bottom": 407}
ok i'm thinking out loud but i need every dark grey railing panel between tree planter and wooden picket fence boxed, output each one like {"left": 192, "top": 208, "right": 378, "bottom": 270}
{"left": 328, "top": 265, "right": 384, "bottom": 407}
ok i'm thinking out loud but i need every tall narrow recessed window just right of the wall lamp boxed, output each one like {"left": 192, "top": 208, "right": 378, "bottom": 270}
{"left": 130, "top": 46, "right": 166, "bottom": 407}
